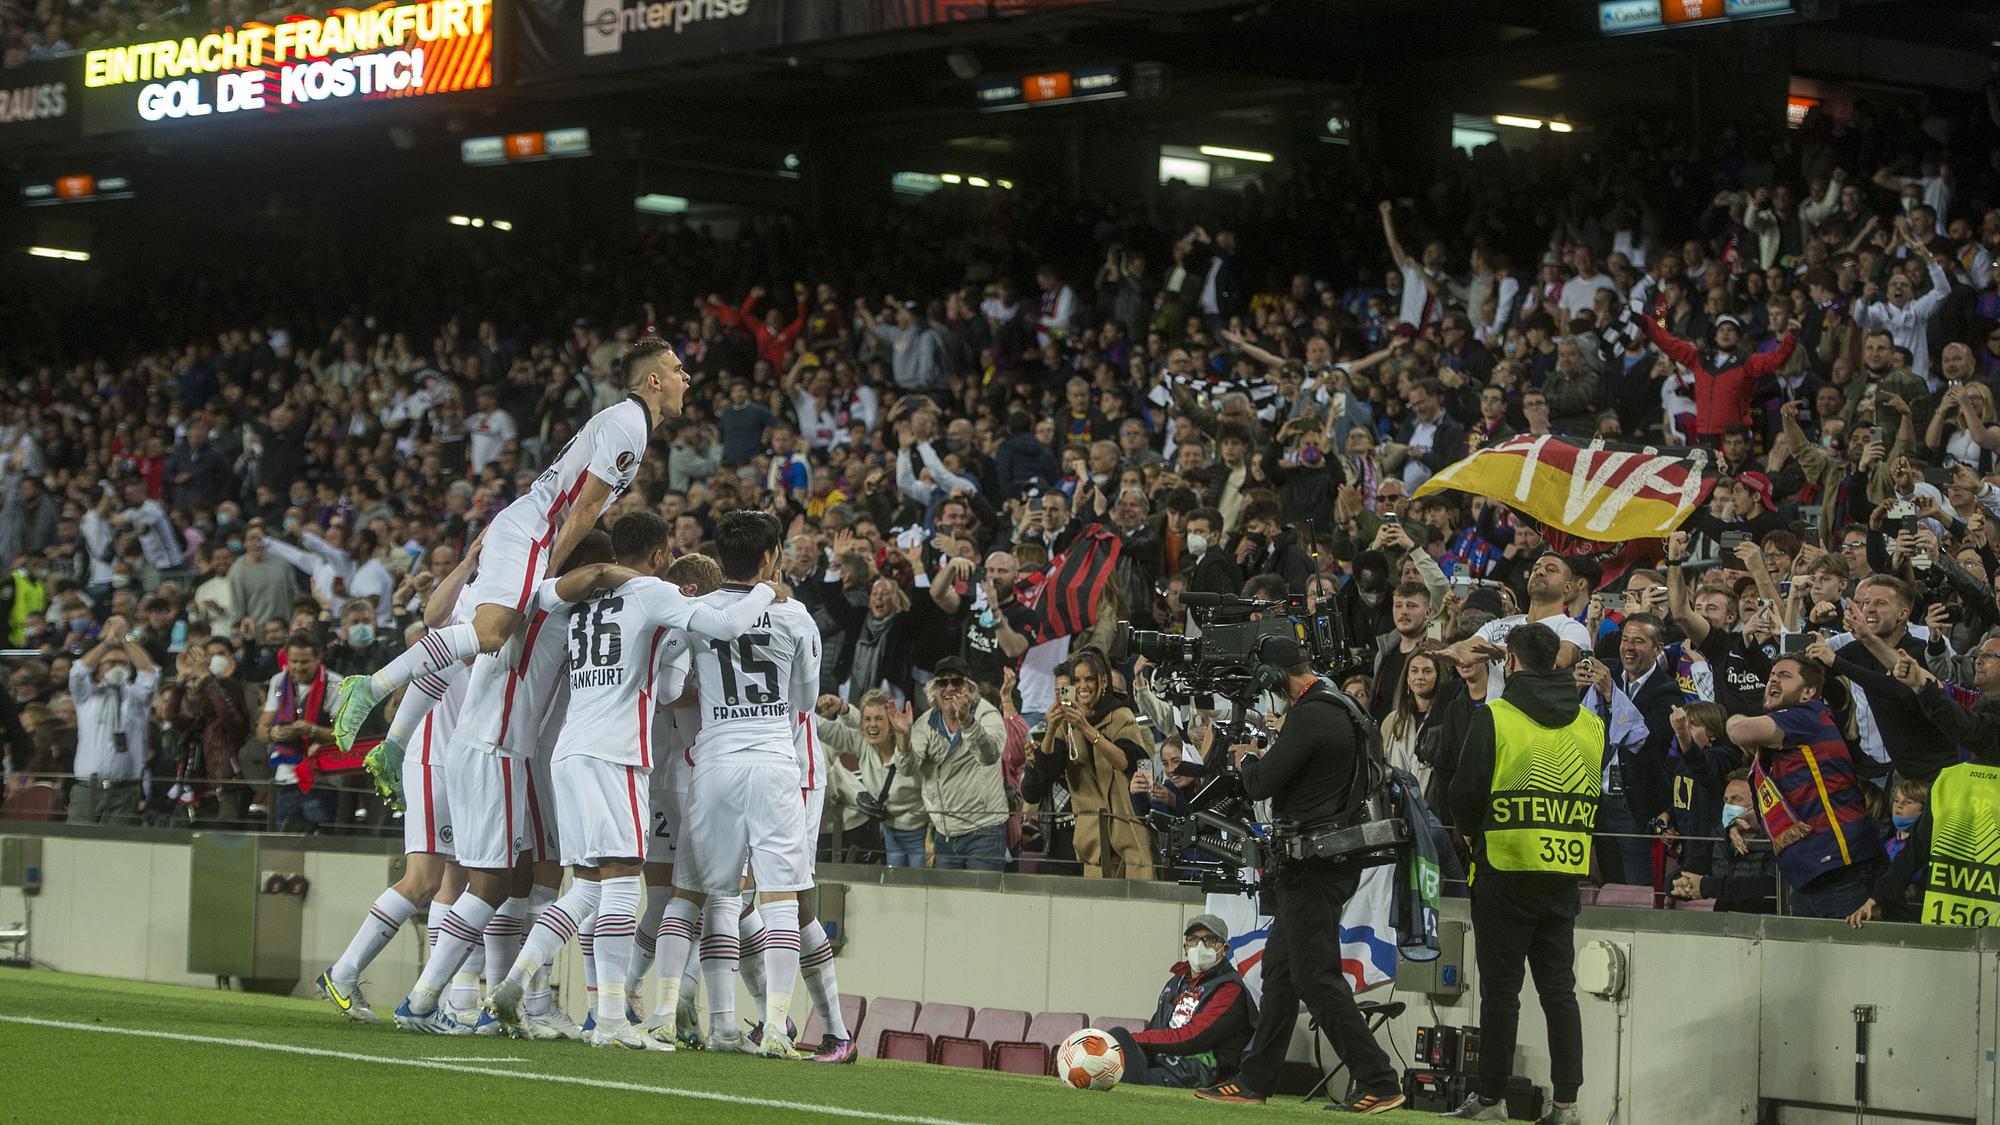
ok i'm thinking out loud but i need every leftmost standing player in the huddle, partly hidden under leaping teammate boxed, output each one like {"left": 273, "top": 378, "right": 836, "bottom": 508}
{"left": 318, "top": 546, "right": 478, "bottom": 1023}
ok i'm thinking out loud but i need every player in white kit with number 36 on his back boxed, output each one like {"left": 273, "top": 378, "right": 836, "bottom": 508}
{"left": 486, "top": 508, "right": 784, "bottom": 1049}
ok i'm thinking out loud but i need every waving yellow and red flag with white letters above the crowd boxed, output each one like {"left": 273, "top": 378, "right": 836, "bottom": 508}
{"left": 1414, "top": 434, "right": 1716, "bottom": 542}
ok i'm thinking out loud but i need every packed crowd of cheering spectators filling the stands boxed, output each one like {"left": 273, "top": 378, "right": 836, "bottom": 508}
{"left": 0, "top": 94, "right": 2000, "bottom": 915}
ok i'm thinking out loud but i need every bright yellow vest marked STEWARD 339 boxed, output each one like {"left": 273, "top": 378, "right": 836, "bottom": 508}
{"left": 1484, "top": 699, "right": 1604, "bottom": 877}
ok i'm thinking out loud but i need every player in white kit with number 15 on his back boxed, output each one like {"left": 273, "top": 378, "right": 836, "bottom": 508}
{"left": 656, "top": 510, "right": 820, "bottom": 1059}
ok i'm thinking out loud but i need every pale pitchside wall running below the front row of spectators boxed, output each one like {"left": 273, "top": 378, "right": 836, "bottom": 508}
{"left": 0, "top": 825, "right": 2000, "bottom": 1125}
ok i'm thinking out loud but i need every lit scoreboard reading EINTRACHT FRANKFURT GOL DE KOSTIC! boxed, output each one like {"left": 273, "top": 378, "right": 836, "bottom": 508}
{"left": 84, "top": 0, "right": 492, "bottom": 132}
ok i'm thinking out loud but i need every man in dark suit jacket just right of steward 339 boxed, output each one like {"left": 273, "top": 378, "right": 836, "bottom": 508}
{"left": 1586, "top": 613, "right": 1680, "bottom": 885}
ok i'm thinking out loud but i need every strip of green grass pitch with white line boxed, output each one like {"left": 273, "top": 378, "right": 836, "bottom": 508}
{"left": 0, "top": 969, "right": 1436, "bottom": 1125}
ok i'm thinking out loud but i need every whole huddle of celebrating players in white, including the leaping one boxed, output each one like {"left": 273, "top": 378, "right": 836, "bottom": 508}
{"left": 318, "top": 336, "right": 856, "bottom": 1063}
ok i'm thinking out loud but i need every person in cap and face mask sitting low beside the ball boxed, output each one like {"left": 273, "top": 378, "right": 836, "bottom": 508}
{"left": 1112, "top": 915, "right": 1256, "bottom": 1089}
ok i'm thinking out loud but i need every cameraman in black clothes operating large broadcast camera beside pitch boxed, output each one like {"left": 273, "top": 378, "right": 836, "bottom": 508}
{"left": 1196, "top": 637, "right": 1404, "bottom": 1115}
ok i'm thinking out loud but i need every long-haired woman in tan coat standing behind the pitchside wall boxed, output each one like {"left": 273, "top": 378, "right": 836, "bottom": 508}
{"left": 1022, "top": 649, "right": 1152, "bottom": 879}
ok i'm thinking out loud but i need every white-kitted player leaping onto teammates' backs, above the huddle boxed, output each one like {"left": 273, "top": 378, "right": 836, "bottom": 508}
{"left": 334, "top": 336, "right": 688, "bottom": 751}
